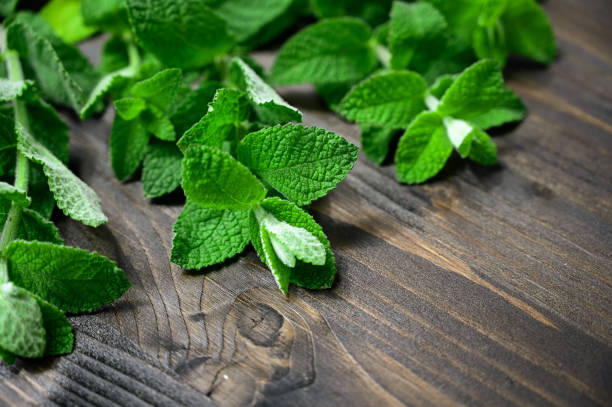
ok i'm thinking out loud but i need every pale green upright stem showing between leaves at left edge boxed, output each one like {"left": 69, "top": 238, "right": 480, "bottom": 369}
{"left": 0, "top": 50, "right": 30, "bottom": 283}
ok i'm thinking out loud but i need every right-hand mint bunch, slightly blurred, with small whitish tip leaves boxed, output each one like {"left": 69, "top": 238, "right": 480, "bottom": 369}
{"left": 271, "top": 0, "right": 556, "bottom": 184}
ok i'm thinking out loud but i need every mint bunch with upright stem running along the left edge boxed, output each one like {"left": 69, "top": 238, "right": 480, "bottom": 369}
{"left": 0, "top": 7, "right": 130, "bottom": 364}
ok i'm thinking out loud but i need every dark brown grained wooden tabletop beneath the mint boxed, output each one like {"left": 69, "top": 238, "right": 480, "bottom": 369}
{"left": 0, "top": 0, "right": 612, "bottom": 406}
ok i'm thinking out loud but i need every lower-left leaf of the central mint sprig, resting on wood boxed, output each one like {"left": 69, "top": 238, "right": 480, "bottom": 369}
{"left": 170, "top": 201, "right": 250, "bottom": 269}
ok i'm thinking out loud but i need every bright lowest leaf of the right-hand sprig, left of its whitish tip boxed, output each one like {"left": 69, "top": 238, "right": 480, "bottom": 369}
{"left": 395, "top": 112, "right": 453, "bottom": 184}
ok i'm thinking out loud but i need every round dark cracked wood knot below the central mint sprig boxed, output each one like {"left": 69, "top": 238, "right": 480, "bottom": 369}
{"left": 238, "top": 303, "right": 285, "bottom": 347}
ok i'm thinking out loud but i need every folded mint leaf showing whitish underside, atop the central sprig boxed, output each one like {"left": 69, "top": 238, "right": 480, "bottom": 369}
{"left": 230, "top": 58, "right": 302, "bottom": 124}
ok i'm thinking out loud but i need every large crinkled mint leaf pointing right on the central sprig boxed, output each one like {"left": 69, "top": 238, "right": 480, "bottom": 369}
{"left": 238, "top": 124, "right": 359, "bottom": 206}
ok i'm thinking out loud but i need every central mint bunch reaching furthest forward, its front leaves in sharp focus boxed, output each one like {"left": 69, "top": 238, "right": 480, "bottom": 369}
{"left": 71, "top": 0, "right": 359, "bottom": 294}
